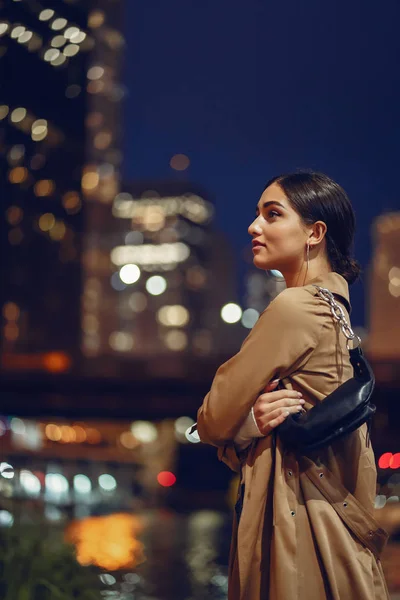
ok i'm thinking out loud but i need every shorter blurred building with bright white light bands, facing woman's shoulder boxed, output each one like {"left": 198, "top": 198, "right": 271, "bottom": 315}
{"left": 83, "top": 182, "right": 244, "bottom": 375}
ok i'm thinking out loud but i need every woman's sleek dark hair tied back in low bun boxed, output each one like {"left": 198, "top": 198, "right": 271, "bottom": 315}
{"left": 265, "top": 171, "right": 361, "bottom": 284}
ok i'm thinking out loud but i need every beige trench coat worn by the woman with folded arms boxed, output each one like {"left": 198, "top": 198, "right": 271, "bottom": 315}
{"left": 198, "top": 272, "right": 389, "bottom": 600}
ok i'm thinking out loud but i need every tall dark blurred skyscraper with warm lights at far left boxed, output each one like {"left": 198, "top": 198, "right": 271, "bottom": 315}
{"left": 0, "top": 0, "right": 124, "bottom": 370}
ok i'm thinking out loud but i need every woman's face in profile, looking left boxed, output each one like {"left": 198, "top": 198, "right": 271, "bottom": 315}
{"left": 248, "top": 183, "right": 309, "bottom": 274}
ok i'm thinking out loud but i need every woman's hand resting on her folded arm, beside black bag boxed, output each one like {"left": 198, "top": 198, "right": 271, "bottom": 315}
{"left": 253, "top": 379, "right": 305, "bottom": 435}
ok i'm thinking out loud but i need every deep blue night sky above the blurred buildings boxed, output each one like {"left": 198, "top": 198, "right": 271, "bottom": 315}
{"left": 123, "top": 0, "right": 400, "bottom": 325}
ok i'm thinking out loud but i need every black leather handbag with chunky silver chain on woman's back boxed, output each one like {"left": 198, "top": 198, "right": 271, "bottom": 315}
{"left": 276, "top": 285, "right": 376, "bottom": 454}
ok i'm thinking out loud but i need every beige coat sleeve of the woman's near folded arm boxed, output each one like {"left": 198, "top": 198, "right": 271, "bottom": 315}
{"left": 197, "top": 288, "right": 323, "bottom": 450}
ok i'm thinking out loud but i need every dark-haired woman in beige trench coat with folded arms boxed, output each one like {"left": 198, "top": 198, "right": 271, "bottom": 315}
{"left": 197, "top": 172, "right": 389, "bottom": 600}
